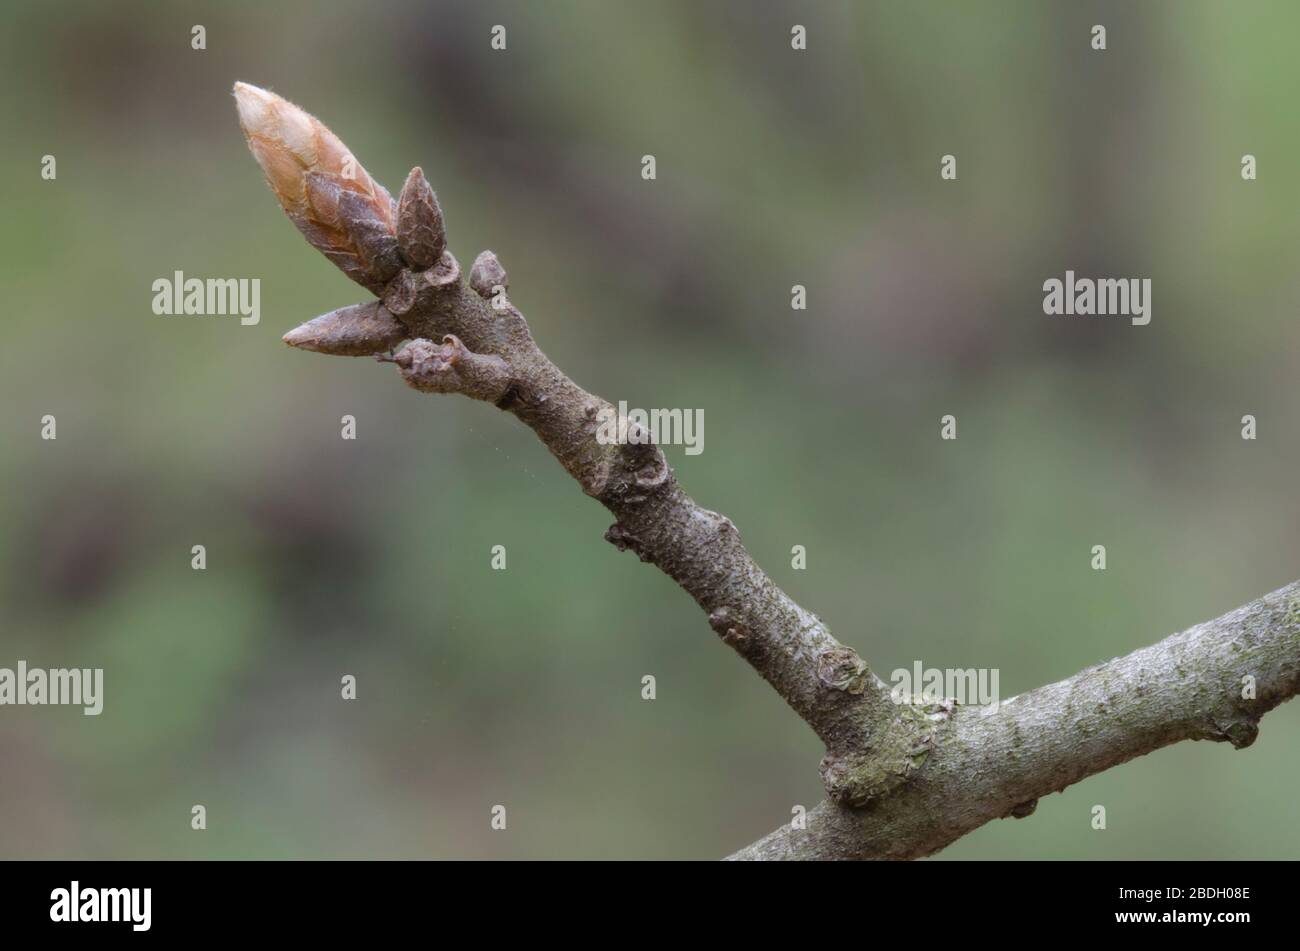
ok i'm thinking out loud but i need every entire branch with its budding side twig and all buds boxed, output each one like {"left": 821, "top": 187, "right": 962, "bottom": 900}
{"left": 235, "top": 83, "right": 1300, "bottom": 857}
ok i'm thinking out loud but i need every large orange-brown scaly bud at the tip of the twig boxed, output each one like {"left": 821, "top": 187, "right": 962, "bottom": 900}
{"left": 234, "top": 83, "right": 400, "bottom": 292}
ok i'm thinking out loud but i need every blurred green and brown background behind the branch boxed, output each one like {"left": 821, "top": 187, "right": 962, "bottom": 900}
{"left": 0, "top": 0, "right": 1300, "bottom": 859}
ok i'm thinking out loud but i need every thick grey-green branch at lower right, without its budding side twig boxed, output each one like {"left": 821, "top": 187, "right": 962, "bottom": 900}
{"left": 731, "top": 582, "right": 1300, "bottom": 859}
